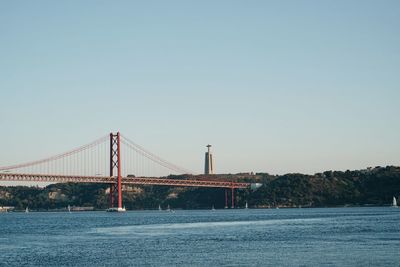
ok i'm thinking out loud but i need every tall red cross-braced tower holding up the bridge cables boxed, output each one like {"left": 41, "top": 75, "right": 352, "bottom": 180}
{"left": 110, "top": 132, "right": 122, "bottom": 210}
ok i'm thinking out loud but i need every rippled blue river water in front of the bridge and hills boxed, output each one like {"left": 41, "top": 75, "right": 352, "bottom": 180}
{"left": 0, "top": 207, "right": 400, "bottom": 266}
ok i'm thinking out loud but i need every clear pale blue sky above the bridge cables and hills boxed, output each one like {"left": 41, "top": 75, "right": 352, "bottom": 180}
{"left": 0, "top": 0, "right": 400, "bottom": 176}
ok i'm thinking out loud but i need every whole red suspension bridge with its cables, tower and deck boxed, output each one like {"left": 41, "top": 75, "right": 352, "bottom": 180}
{"left": 0, "top": 132, "right": 257, "bottom": 210}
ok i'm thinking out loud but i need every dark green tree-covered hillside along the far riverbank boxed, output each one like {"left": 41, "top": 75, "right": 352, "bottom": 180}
{"left": 0, "top": 166, "right": 400, "bottom": 210}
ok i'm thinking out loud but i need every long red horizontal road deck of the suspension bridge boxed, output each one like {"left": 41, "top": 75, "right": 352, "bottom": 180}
{"left": 0, "top": 173, "right": 251, "bottom": 189}
